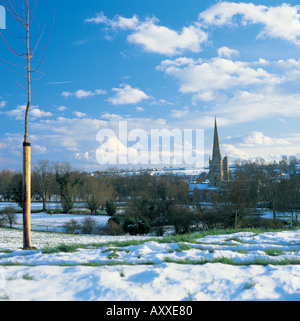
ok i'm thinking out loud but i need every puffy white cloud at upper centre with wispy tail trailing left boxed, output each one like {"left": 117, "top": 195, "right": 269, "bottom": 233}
{"left": 85, "top": 13, "right": 207, "bottom": 56}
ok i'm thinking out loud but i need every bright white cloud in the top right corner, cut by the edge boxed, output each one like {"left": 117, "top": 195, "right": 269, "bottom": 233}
{"left": 199, "top": 2, "right": 300, "bottom": 45}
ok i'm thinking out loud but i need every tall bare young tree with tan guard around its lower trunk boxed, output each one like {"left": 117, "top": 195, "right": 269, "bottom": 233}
{"left": 0, "top": 0, "right": 52, "bottom": 249}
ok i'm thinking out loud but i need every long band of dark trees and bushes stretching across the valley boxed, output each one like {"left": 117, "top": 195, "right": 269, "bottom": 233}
{"left": 0, "top": 158, "right": 300, "bottom": 235}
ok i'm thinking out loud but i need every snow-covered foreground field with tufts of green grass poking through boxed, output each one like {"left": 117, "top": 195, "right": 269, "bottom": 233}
{"left": 0, "top": 229, "right": 300, "bottom": 301}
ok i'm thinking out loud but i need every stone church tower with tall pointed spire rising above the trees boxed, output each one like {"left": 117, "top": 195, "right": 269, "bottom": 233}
{"left": 209, "top": 118, "right": 229, "bottom": 187}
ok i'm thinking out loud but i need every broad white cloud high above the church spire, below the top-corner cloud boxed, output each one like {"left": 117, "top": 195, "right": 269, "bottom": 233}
{"left": 157, "top": 57, "right": 283, "bottom": 101}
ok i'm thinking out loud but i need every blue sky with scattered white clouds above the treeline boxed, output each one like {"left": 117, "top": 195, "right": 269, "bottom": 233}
{"left": 0, "top": 0, "right": 300, "bottom": 170}
